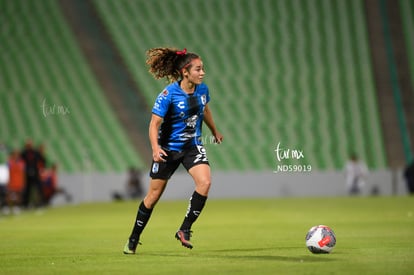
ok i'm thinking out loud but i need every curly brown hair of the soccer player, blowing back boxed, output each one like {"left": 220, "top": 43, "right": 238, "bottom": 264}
{"left": 145, "top": 47, "right": 200, "bottom": 82}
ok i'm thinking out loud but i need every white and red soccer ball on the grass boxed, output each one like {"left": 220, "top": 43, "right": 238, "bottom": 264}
{"left": 305, "top": 225, "right": 336, "bottom": 254}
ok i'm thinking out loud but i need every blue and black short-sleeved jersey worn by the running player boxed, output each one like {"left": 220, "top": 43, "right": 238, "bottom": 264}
{"left": 152, "top": 81, "right": 210, "bottom": 151}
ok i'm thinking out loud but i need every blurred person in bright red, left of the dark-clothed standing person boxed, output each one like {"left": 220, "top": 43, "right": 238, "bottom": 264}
{"left": 7, "top": 150, "right": 25, "bottom": 212}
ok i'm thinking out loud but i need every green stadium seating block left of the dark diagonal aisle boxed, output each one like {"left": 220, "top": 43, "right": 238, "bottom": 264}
{"left": 0, "top": 0, "right": 144, "bottom": 172}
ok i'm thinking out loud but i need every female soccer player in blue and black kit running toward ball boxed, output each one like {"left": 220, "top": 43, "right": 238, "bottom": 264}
{"left": 124, "top": 48, "right": 223, "bottom": 254}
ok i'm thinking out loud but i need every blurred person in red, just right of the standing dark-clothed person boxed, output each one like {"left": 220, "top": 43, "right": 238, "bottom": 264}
{"left": 41, "top": 163, "right": 72, "bottom": 205}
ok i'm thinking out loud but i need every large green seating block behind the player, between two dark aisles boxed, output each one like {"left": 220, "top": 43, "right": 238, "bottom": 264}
{"left": 94, "top": 0, "right": 386, "bottom": 170}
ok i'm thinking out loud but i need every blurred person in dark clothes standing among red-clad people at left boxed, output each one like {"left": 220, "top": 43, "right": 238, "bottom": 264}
{"left": 21, "top": 139, "right": 45, "bottom": 208}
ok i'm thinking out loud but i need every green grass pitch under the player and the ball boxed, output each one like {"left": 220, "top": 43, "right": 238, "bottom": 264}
{"left": 0, "top": 197, "right": 414, "bottom": 274}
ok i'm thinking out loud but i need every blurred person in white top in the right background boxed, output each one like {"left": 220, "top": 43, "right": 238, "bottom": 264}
{"left": 345, "top": 153, "right": 368, "bottom": 195}
